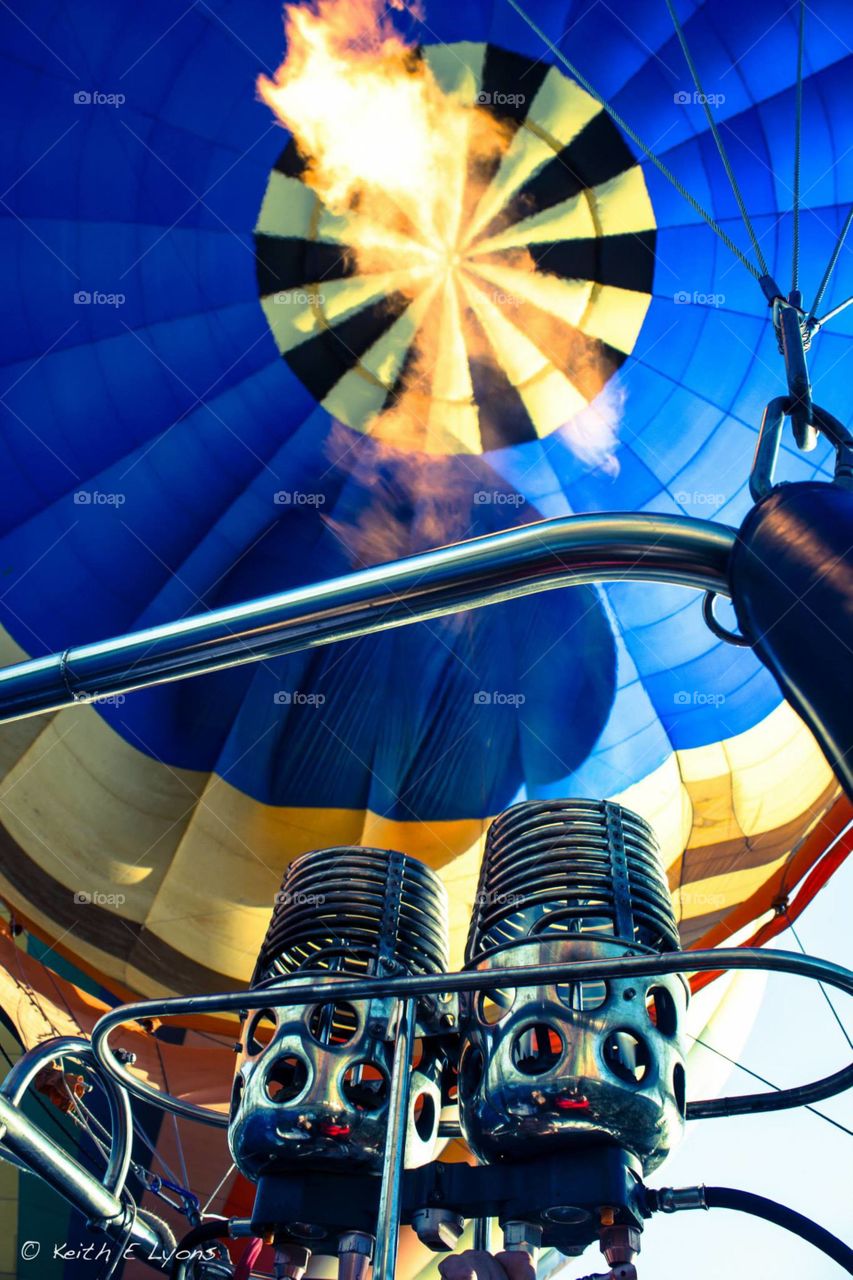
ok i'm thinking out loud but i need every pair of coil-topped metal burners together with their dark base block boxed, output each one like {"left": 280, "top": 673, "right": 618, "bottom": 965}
{"left": 229, "top": 800, "right": 688, "bottom": 1280}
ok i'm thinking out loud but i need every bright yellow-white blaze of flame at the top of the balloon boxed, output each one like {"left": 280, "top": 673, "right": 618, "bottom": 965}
{"left": 257, "top": 0, "right": 506, "bottom": 289}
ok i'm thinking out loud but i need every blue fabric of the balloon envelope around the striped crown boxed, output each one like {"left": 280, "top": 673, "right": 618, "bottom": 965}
{"left": 0, "top": 0, "right": 853, "bottom": 818}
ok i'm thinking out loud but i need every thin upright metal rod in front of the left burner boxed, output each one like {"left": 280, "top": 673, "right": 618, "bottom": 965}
{"left": 373, "top": 1000, "right": 415, "bottom": 1280}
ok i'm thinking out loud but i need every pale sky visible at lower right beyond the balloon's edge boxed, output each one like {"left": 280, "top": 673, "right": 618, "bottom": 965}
{"left": 561, "top": 859, "right": 853, "bottom": 1280}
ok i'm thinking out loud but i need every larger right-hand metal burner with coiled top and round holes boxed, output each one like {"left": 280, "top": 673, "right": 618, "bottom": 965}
{"left": 459, "top": 800, "right": 688, "bottom": 1171}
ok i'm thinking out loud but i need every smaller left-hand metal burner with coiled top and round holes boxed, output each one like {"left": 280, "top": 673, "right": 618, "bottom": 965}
{"left": 228, "top": 847, "right": 448, "bottom": 1180}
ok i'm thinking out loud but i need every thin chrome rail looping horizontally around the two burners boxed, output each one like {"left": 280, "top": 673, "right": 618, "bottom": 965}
{"left": 92, "top": 947, "right": 853, "bottom": 1129}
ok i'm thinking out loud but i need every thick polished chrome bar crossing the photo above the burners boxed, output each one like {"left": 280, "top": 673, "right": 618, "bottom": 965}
{"left": 0, "top": 515, "right": 735, "bottom": 723}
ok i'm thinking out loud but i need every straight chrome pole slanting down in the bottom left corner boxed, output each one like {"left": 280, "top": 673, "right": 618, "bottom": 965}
{"left": 0, "top": 1094, "right": 172, "bottom": 1270}
